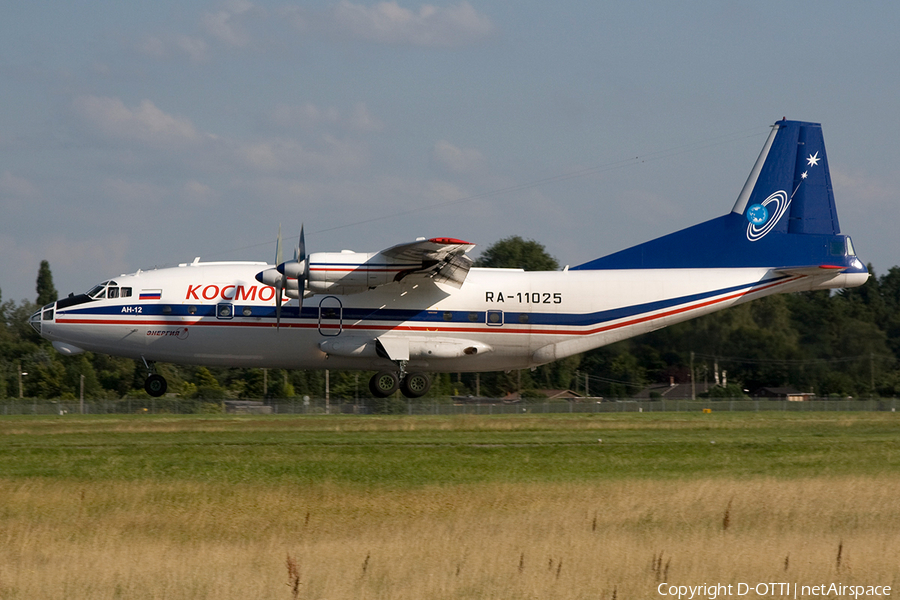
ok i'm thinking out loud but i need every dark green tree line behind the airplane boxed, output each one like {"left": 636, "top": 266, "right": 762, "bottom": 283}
{"left": 0, "top": 241, "right": 900, "bottom": 403}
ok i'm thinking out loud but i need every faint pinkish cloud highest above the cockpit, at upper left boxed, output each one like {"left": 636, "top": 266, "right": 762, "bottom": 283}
{"left": 74, "top": 96, "right": 200, "bottom": 144}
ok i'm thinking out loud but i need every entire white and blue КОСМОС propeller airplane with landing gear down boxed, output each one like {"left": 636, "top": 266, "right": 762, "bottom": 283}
{"left": 30, "top": 119, "right": 869, "bottom": 398}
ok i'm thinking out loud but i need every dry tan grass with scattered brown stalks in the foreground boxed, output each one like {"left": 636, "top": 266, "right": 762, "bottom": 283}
{"left": 0, "top": 477, "right": 900, "bottom": 600}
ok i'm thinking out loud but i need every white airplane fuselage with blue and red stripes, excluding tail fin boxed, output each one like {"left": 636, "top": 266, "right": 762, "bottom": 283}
{"left": 41, "top": 263, "right": 867, "bottom": 372}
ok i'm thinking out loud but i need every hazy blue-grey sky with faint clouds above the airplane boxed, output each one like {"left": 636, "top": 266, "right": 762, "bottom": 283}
{"left": 0, "top": 0, "right": 900, "bottom": 301}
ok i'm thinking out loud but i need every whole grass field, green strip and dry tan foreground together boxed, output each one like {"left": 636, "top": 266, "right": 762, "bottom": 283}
{"left": 0, "top": 413, "right": 900, "bottom": 600}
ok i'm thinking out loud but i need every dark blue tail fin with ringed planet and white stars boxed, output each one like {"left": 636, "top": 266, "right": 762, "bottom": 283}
{"left": 573, "top": 120, "right": 865, "bottom": 272}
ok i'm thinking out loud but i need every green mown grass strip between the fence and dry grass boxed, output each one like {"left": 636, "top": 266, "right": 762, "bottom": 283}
{"left": 0, "top": 413, "right": 900, "bottom": 488}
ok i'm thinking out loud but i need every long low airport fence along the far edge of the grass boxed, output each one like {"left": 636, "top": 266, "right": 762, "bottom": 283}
{"left": 0, "top": 398, "right": 900, "bottom": 416}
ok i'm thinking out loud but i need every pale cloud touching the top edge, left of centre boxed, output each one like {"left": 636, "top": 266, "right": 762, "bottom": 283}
{"left": 333, "top": 0, "right": 494, "bottom": 47}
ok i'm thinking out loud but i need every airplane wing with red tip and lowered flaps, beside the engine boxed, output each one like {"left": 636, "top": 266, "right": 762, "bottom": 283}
{"left": 381, "top": 238, "right": 475, "bottom": 288}
